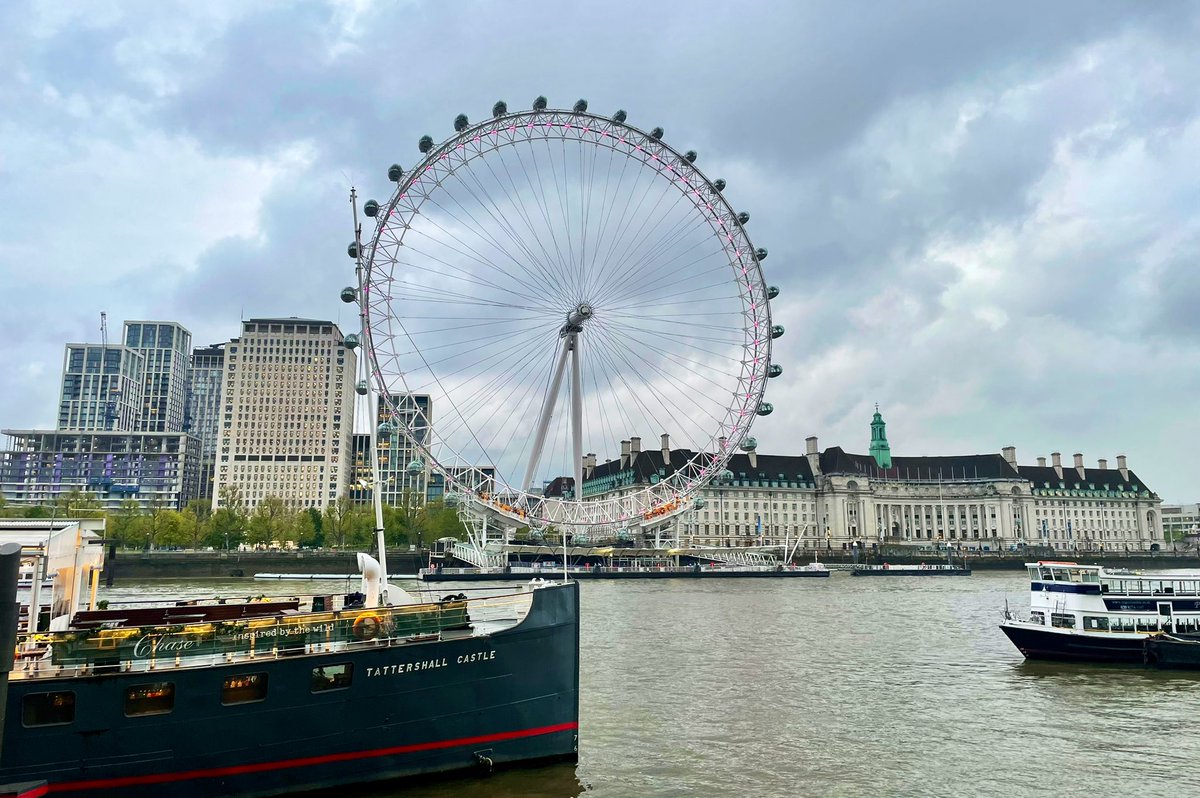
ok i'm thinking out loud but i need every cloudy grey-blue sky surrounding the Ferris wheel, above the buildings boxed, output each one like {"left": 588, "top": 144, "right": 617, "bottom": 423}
{"left": 0, "top": 0, "right": 1200, "bottom": 502}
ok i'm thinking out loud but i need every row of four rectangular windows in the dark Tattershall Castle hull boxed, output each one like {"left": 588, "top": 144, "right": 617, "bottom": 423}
{"left": 20, "top": 662, "right": 354, "bottom": 726}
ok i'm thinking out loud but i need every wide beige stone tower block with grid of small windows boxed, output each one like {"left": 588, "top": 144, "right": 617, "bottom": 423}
{"left": 212, "top": 318, "right": 355, "bottom": 509}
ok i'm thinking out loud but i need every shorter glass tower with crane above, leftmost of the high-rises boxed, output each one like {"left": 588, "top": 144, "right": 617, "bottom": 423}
{"left": 58, "top": 343, "right": 145, "bottom": 431}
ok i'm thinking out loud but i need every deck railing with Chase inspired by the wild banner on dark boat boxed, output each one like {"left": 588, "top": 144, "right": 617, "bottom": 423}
{"left": 10, "top": 592, "right": 533, "bottom": 678}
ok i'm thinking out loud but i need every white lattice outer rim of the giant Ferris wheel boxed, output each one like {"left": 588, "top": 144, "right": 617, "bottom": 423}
{"left": 360, "top": 109, "right": 773, "bottom": 526}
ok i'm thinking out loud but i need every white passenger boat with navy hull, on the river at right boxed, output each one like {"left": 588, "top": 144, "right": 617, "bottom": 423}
{"left": 1000, "top": 562, "right": 1200, "bottom": 662}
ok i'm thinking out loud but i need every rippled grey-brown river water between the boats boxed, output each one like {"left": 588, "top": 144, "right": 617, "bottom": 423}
{"left": 103, "top": 571, "right": 1200, "bottom": 798}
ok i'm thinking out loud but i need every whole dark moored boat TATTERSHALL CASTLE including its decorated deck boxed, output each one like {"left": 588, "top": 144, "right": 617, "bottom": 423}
{"left": 0, "top": 544, "right": 578, "bottom": 798}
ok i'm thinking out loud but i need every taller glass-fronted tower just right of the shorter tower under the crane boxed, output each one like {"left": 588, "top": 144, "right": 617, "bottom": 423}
{"left": 125, "top": 322, "right": 192, "bottom": 432}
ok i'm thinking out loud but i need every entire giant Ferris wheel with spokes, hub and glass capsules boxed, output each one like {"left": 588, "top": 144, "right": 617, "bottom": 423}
{"left": 343, "top": 97, "right": 784, "bottom": 528}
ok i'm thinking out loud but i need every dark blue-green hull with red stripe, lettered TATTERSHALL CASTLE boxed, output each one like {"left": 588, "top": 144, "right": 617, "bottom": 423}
{"left": 0, "top": 583, "right": 578, "bottom": 798}
